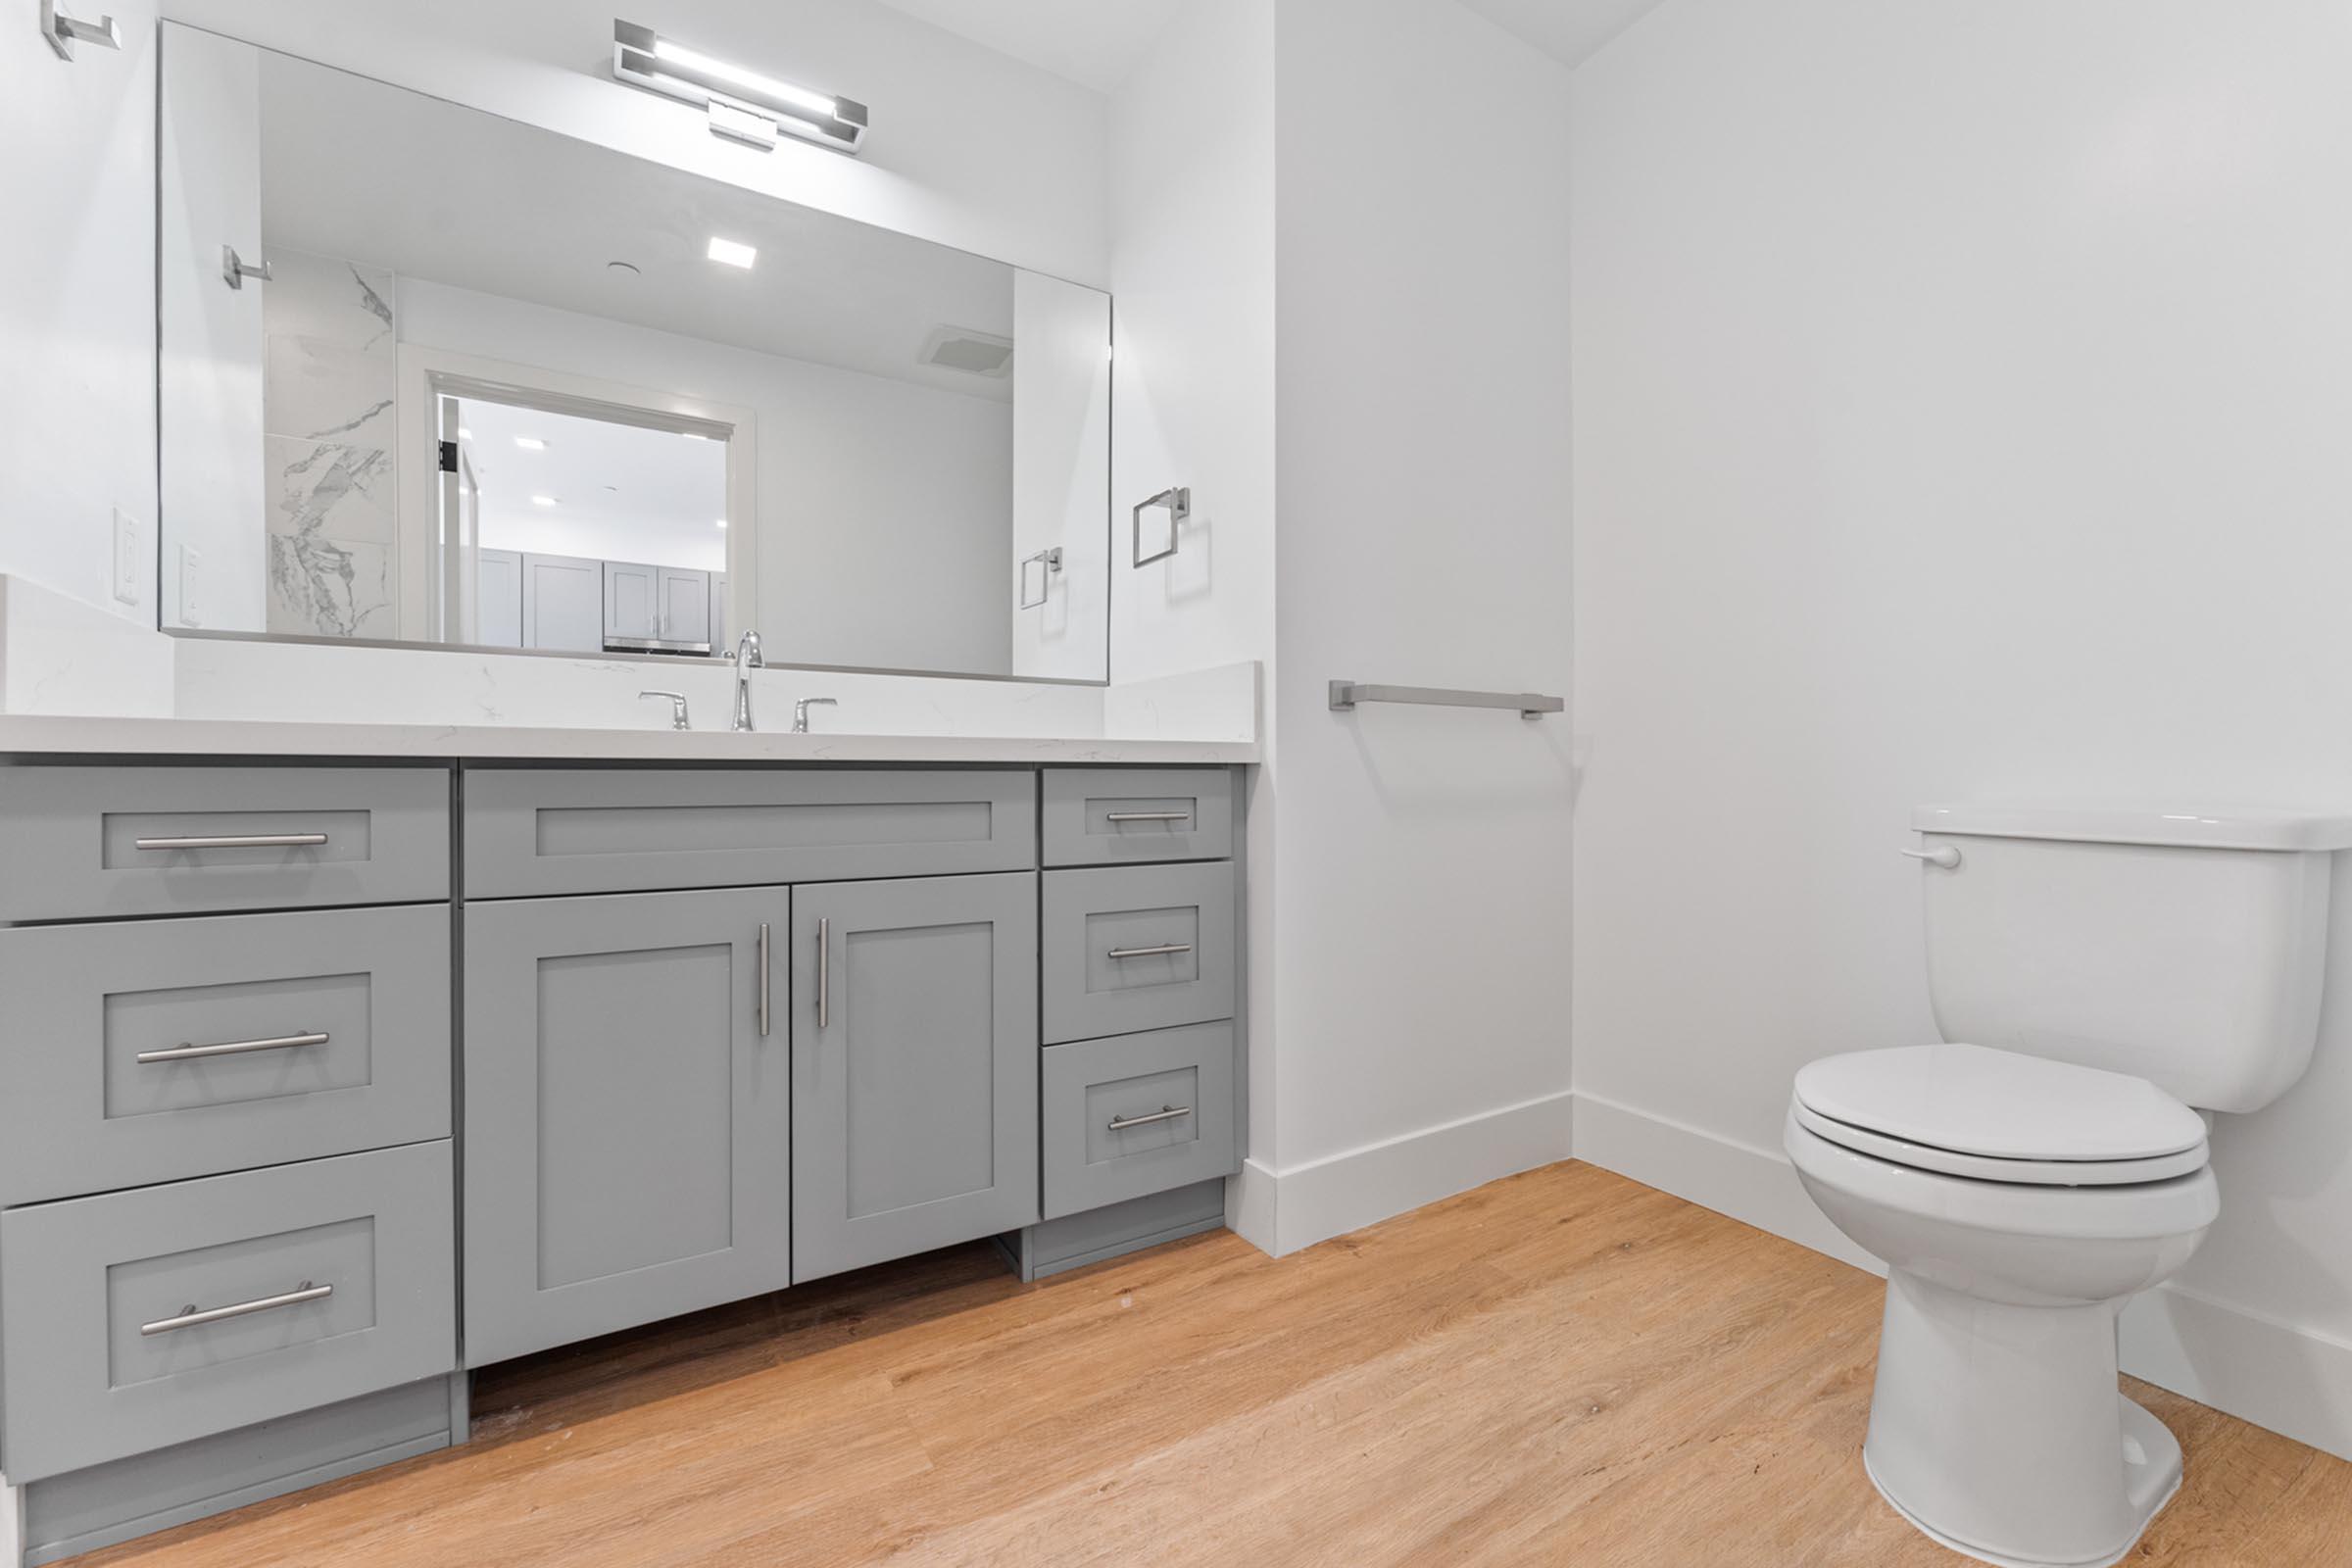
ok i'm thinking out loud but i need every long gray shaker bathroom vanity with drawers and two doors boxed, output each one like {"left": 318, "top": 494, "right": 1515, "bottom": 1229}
{"left": 0, "top": 738, "right": 1247, "bottom": 1563}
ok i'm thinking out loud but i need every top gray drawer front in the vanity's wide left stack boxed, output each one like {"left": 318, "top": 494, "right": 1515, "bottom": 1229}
{"left": 0, "top": 764, "right": 449, "bottom": 921}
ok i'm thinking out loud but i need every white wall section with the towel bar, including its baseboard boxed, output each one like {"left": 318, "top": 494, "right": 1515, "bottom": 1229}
{"left": 1251, "top": 0, "right": 1571, "bottom": 1250}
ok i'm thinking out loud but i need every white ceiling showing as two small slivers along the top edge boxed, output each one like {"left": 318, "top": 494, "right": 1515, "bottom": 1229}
{"left": 880, "top": 0, "right": 1665, "bottom": 92}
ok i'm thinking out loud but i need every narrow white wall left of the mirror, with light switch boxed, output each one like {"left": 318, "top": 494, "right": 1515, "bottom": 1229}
{"left": 0, "top": 0, "right": 155, "bottom": 623}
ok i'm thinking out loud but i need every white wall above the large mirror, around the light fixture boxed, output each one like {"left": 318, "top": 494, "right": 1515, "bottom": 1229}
{"left": 173, "top": 0, "right": 1107, "bottom": 284}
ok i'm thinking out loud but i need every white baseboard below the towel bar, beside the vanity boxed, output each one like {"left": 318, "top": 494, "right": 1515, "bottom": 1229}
{"left": 1228, "top": 1093, "right": 1571, "bottom": 1257}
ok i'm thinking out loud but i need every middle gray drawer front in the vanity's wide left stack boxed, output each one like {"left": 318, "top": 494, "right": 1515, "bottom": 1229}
{"left": 0, "top": 903, "right": 449, "bottom": 1206}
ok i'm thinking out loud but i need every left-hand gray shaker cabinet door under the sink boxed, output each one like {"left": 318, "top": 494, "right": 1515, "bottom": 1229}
{"left": 464, "top": 889, "right": 793, "bottom": 1366}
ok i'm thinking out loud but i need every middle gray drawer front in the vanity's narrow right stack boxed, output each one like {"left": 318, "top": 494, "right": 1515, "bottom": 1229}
{"left": 1040, "top": 862, "right": 1233, "bottom": 1044}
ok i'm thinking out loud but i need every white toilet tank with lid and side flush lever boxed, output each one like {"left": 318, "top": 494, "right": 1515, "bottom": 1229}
{"left": 1912, "top": 804, "right": 2352, "bottom": 1112}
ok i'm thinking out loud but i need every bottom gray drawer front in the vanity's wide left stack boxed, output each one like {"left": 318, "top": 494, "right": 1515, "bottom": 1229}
{"left": 0, "top": 1143, "right": 457, "bottom": 1484}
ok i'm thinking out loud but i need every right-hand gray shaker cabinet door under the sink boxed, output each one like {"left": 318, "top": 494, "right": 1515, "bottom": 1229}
{"left": 793, "top": 872, "right": 1040, "bottom": 1279}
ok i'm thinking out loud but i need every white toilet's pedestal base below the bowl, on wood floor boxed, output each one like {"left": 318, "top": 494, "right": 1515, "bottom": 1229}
{"left": 1863, "top": 1269, "right": 2180, "bottom": 1568}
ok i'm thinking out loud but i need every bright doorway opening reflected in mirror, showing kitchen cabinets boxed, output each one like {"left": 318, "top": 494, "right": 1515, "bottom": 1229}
{"left": 433, "top": 376, "right": 731, "bottom": 659}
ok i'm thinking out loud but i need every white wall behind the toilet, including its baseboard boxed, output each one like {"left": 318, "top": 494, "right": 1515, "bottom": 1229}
{"left": 1574, "top": 0, "right": 2352, "bottom": 1452}
